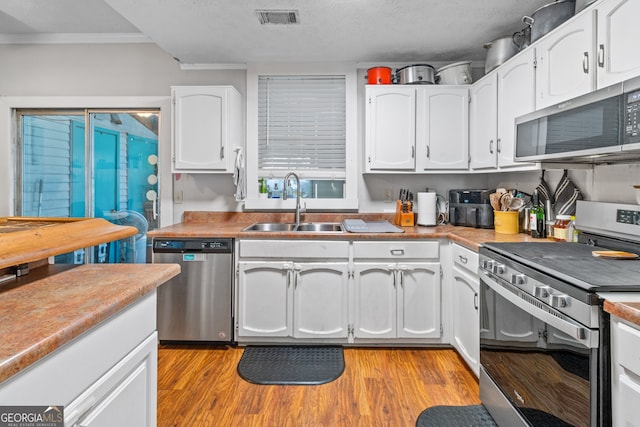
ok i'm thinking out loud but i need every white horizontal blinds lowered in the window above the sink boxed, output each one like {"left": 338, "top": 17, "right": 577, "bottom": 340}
{"left": 258, "top": 76, "right": 346, "bottom": 171}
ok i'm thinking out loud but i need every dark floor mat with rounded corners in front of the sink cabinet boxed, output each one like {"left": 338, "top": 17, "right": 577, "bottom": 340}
{"left": 238, "top": 346, "right": 344, "bottom": 385}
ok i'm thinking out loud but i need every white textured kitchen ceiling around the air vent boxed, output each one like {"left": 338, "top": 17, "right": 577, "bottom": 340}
{"left": 0, "top": 0, "right": 585, "bottom": 64}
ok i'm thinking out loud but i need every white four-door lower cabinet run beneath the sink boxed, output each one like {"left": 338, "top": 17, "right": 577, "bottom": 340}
{"left": 236, "top": 240, "right": 447, "bottom": 344}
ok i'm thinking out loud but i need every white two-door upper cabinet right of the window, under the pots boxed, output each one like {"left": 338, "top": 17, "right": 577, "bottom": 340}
{"left": 365, "top": 85, "right": 469, "bottom": 173}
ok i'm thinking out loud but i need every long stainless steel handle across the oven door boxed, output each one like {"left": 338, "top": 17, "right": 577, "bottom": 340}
{"left": 481, "top": 270, "right": 599, "bottom": 348}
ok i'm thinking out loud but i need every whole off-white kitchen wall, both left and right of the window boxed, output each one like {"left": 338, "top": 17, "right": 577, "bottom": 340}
{"left": 0, "top": 44, "right": 640, "bottom": 222}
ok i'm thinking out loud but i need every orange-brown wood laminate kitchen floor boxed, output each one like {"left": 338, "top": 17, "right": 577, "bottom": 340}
{"left": 158, "top": 345, "right": 480, "bottom": 427}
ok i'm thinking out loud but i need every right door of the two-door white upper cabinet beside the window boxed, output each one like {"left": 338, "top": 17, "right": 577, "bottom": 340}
{"left": 416, "top": 85, "right": 469, "bottom": 171}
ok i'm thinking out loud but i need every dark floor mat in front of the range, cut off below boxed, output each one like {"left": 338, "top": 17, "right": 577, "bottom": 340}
{"left": 416, "top": 405, "right": 497, "bottom": 427}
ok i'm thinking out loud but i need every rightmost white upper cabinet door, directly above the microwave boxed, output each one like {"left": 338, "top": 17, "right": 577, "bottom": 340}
{"left": 596, "top": 0, "right": 640, "bottom": 87}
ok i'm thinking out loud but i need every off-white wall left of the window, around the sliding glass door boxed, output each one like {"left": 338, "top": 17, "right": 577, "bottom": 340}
{"left": 0, "top": 44, "right": 246, "bottom": 224}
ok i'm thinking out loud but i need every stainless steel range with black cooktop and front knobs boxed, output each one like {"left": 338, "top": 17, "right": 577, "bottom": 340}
{"left": 479, "top": 201, "right": 640, "bottom": 426}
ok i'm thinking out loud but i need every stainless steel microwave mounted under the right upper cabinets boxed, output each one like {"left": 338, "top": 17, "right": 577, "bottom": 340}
{"left": 515, "top": 77, "right": 640, "bottom": 163}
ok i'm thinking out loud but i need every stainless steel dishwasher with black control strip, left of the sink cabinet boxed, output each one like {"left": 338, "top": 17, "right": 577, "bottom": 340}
{"left": 153, "top": 238, "right": 233, "bottom": 343}
